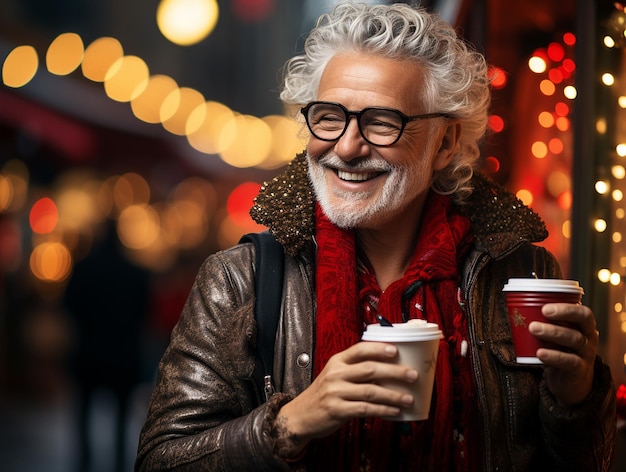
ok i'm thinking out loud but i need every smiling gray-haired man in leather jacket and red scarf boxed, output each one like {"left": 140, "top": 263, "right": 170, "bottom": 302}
{"left": 136, "top": 4, "right": 615, "bottom": 471}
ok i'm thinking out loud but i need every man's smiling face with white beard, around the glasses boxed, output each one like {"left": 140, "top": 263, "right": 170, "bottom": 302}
{"left": 307, "top": 52, "right": 456, "bottom": 229}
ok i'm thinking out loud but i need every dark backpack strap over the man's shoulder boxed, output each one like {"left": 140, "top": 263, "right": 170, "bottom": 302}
{"left": 239, "top": 231, "right": 285, "bottom": 400}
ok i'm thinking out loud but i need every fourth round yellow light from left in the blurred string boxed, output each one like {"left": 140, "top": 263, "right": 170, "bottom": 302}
{"left": 104, "top": 56, "right": 150, "bottom": 102}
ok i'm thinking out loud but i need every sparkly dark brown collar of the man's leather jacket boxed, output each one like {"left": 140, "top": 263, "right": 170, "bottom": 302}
{"left": 250, "top": 153, "right": 548, "bottom": 259}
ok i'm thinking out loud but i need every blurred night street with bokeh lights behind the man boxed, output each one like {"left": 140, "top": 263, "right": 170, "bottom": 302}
{"left": 0, "top": 0, "right": 626, "bottom": 472}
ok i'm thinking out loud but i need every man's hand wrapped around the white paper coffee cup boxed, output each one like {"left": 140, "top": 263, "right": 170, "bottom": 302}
{"left": 274, "top": 342, "right": 418, "bottom": 458}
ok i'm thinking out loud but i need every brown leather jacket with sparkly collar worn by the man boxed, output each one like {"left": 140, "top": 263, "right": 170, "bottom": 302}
{"left": 135, "top": 156, "right": 615, "bottom": 472}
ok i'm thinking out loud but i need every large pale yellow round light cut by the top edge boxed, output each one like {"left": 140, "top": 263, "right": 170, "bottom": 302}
{"left": 157, "top": 0, "right": 219, "bottom": 46}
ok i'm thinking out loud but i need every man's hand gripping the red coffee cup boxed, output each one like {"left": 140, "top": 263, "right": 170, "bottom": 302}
{"left": 528, "top": 303, "right": 599, "bottom": 406}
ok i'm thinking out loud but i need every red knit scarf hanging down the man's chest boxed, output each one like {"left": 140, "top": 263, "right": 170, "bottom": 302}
{"left": 309, "top": 192, "right": 481, "bottom": 472}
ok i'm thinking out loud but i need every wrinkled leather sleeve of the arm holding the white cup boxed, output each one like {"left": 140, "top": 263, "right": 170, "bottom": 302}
{"left": 135, "top": 244, "right": 291, "bottom": 471}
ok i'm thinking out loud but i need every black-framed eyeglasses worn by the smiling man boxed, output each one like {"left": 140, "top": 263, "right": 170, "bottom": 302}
{"left": 300, "top": 102, "right": 450, "bottom": 146}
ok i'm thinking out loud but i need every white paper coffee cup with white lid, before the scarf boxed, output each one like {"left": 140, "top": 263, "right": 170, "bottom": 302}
{"left": 362, "top": 320, "right": 443, "bottom": 421}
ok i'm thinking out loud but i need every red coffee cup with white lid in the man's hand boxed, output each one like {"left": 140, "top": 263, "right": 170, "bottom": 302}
{"left": 502, "top": 278, "right": 584, "bottom": 364}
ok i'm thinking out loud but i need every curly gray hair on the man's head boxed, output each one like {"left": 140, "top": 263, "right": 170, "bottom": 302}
{"left": 280, "top": 3, "right": 490, "bottom": 203}
